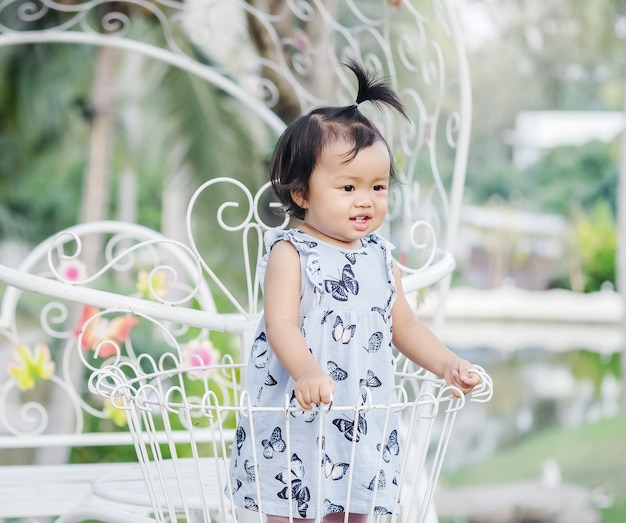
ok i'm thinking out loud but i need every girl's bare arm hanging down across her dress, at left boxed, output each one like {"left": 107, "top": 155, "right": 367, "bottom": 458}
{"left": 264, "top": 241, "right": 335, "bottom": 409}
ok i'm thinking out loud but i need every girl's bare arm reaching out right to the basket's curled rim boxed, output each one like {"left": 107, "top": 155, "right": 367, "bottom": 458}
{"left": 391, "top": 263, "right": 480, "bottom": 393}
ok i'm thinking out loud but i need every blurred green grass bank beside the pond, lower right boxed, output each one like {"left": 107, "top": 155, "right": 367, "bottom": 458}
{"left": 440, "top": 415, "right": 626, "bottom": 523}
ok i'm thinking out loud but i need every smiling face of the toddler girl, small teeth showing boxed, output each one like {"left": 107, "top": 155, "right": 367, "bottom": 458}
{"left": 292, "top": 142, "right": 391, "bottom": 249}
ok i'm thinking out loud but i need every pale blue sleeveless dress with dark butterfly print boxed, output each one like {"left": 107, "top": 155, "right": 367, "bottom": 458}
{"left": 231, "top": 229, "right": 400, "bottom": 518}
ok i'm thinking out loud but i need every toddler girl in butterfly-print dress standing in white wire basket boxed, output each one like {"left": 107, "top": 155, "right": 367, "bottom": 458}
{"left": 231, "top": 62, "right": 479, "bottom": 523}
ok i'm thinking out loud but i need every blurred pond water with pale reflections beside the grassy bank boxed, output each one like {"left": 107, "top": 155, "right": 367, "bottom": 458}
{"left": 444, "top": 349, "right": 621, "bottom": 472}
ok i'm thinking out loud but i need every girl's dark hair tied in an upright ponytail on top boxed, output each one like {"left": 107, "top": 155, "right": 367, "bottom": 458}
{"left": 269, "top": 61, "right": 408, "bottom": 219}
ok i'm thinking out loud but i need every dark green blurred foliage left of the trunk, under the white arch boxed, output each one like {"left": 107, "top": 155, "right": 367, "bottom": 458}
{"left": 0, "top": 44, "right": 93, "bottom": 239}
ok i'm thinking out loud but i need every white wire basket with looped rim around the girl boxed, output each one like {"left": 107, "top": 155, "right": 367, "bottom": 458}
{"left": 90, "top": 356, "right": 492, "bottom": 523}
